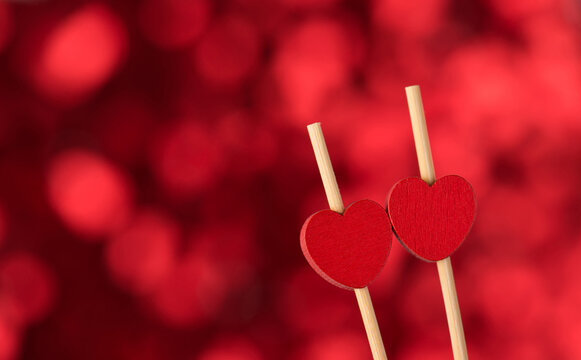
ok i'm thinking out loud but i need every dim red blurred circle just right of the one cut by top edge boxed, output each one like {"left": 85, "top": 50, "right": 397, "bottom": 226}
{"left": 194, "top": 15, "right": 261, "bottom": 86}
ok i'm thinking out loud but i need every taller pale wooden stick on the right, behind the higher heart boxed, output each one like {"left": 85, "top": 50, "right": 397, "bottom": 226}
{"left": 405, "top": 85, "right": 468, "bottom": 360}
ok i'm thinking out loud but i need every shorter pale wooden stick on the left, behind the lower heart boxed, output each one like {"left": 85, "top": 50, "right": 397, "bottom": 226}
{"left": 307, "top": 123, "right": 387, "bottom": 360}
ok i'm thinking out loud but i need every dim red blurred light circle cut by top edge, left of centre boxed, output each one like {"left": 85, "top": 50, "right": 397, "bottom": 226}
{"left": 139, "top": 0, "right": 212, "bottom": 49}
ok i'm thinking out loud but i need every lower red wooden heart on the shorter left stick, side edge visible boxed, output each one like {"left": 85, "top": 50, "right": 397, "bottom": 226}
{"left": 301, "top": 200, "right": 391, "bottom": 290}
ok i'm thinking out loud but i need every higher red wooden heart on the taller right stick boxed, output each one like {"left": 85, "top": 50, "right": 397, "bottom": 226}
{"left": 387, "top": 175, "right": 476, "bottom": 261}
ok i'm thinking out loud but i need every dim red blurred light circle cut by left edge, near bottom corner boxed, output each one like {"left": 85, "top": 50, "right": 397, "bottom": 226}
{"left": 0, "top": 253, "right": 56, "bottom": 325}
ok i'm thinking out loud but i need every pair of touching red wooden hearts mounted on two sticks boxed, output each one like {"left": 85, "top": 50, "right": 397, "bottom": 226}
{"left": 301, "top": 175, "right": 476, "bottom": 289}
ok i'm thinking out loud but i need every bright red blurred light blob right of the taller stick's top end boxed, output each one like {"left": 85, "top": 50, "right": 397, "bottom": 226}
{"left": 434, "top": 41, "right": 534, "bottom": 148}
